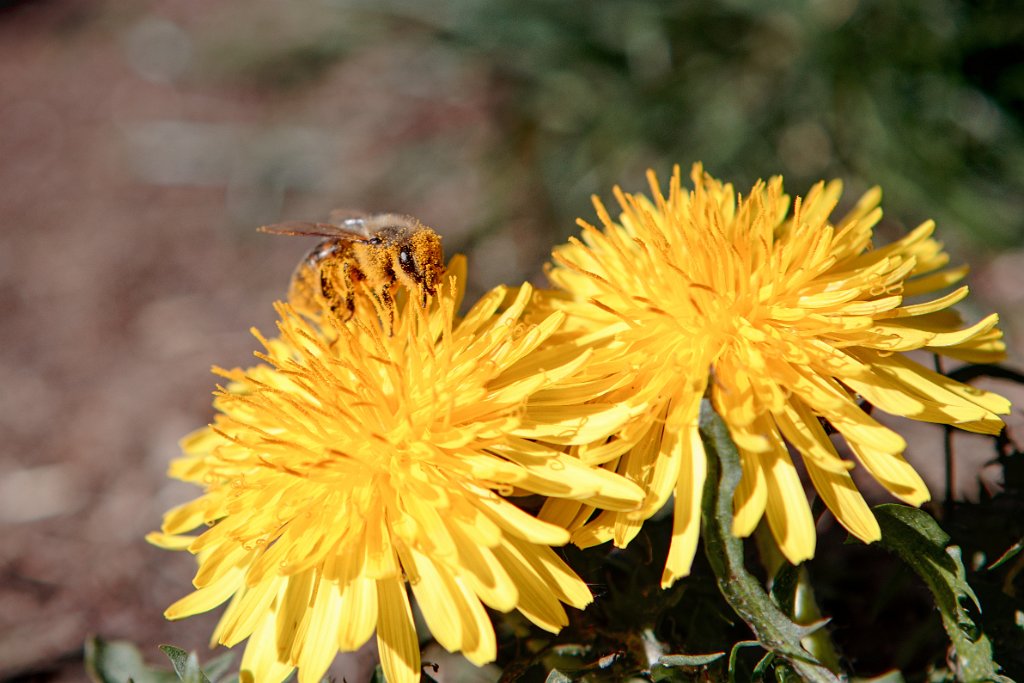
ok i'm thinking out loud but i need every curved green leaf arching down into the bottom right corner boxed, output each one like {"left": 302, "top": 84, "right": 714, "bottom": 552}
{"left": 874, "top": 504, "right": 1013, "bottom": 683}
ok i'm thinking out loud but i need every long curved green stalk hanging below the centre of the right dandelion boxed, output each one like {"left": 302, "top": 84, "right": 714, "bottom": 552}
{"left": 700, "top": 399, "right": 839, "bottom": 683}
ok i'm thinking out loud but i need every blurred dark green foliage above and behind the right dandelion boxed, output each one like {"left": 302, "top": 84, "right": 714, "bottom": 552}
{"left": 211, "top": 0, "right": 1024, "bottom": 246}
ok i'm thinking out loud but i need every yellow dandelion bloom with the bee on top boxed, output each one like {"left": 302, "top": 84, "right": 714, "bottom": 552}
{"left": 150, "top": 259, "right": 643, "bottom": 683}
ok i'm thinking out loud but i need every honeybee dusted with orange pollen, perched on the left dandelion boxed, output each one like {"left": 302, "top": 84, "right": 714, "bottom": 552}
{"left": 259, "top": 211, "right": 444, "bottom": 322}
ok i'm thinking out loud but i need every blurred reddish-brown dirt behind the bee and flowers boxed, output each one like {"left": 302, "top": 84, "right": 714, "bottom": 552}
{"left": 0, "top": 0, "right": 1024, "bottom": 680}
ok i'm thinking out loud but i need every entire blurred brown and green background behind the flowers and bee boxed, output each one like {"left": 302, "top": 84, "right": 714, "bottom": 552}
{"left": 0, "top": 0, "right": 1024, "bottom": 680}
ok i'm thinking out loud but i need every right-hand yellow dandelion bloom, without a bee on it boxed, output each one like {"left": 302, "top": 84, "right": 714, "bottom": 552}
{"left": 541, "top": 165, "right": 1010, "bottom": 585}
